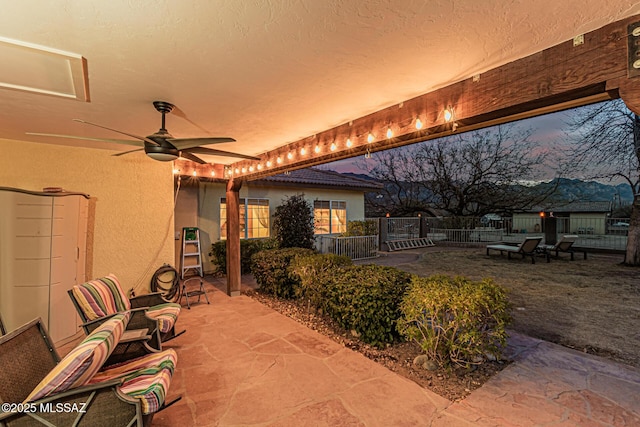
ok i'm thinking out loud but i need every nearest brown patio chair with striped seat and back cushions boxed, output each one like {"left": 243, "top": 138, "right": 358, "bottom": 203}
{"left": 0, "top": 313, "right": 177, "bottom": 427}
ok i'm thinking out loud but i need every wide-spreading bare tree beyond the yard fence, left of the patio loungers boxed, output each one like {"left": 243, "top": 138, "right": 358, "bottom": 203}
{"left": 368, "top": 125, "right": 555, "bottom": 215}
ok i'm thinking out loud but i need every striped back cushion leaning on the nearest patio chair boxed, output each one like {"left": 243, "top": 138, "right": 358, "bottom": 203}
{"left": 25, "top": 312, "right": 130, "bottom": 402}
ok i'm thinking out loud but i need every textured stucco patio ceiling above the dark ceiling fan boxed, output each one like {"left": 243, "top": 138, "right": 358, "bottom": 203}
{"left": 0, "top": 0, "right": 640, "bottom": 163}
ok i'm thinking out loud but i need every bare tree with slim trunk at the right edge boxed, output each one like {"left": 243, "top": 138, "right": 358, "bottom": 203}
{"left": 568, "top": 100, "right": 640, "bottom": 266}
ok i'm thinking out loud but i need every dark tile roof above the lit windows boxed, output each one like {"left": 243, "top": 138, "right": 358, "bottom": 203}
{"left": 251, "top": 168, "right": 383, "bottom": 191}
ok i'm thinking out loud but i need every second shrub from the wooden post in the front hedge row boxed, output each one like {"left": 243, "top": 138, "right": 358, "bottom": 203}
{"left": 289, "top": 254, "right": 353, "bottom": 308}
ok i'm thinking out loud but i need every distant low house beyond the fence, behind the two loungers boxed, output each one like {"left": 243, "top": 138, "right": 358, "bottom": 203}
{"left": 511, "top": 202, "right": 611, "bottom": 234}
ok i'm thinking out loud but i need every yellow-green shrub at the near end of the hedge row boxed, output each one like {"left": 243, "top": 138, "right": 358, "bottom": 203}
{"left": 398, "top": 276, "right": 511, "bottom": 366}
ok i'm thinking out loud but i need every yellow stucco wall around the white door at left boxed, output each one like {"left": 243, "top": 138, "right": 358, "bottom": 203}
{"left": 0, "top": 139, "right": 174, "bottom": 293}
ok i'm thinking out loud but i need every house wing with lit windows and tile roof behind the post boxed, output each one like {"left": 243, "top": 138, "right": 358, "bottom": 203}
{"left": 175, "top": 168, "right": 382, "bottom": 269}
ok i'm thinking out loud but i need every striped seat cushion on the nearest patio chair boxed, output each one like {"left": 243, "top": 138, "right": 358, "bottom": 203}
{"left": 91, "top": 349, "right": 178, "bottom": 414}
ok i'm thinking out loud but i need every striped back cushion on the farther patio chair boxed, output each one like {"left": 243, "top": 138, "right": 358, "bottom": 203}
{"left": 72, "top": 274, "right": 131, "bottom": 320}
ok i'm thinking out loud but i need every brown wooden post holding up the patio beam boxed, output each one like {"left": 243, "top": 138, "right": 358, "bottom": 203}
{"left": 227, "top": 179, "right": 242, "bottom": 297}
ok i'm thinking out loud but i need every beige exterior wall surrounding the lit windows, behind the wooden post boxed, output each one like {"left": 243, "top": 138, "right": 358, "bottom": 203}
{"left": 192, "top": 182, "right": 364, "bottom": 271}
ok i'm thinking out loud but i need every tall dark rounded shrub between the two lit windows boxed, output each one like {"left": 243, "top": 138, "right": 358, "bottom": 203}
{"left": 273, "top": 194, "right": 314, "bottom": 249}
